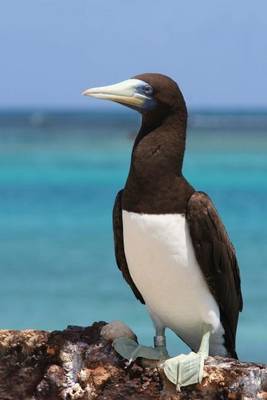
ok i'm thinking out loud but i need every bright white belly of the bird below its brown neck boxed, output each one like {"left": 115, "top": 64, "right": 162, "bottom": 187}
{"left": 123, "top": 210, "right": 226, "bottom": 355}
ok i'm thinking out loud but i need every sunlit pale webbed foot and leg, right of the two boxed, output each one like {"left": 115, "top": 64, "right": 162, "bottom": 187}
{"left": 163, "top": 325, "right": 211, "bottom": 391}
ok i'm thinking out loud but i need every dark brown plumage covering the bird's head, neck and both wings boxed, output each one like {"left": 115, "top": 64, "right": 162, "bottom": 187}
{"left": 108, "top": 74, "right": 242, "bottom": 357}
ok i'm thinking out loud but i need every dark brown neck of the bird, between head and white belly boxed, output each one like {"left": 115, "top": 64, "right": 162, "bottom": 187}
{"left": 123, "top": 106, "right": 193, "bottom": 214}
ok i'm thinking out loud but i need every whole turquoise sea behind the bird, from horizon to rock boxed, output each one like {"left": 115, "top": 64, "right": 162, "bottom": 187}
{"left": 0, "top": 112, "right": 267, "bottom": 362}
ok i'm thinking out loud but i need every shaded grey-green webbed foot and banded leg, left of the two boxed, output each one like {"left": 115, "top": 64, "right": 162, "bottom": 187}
{"left": 113, "top": 329, "right": 168, "bottom": 364}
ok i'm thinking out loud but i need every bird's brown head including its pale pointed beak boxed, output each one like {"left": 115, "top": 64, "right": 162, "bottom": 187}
{"left": 82, "top": 73, "right": 186, "bottom": 118}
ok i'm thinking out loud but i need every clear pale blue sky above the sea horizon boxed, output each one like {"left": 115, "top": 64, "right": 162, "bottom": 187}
{"left": 0, "top": 0, "right": 267, "bottom": 109}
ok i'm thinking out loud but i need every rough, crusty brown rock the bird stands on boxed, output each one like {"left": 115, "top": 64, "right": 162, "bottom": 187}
{"left": 0, "top": 322, "right": 267, "bottom": 400}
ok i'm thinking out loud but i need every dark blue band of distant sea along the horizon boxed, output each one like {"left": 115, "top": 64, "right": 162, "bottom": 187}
{"left": 0, "top": 107, "right": 267, "bottom": 131}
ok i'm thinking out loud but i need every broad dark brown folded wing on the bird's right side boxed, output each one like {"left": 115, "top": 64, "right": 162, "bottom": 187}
{"left": 187, "top": 192, "right": 243, "bottom": 356}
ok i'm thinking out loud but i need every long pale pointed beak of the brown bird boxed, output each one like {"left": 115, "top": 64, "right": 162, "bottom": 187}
{"left": 82, "top": 79, "right": 149, "bottom": 108}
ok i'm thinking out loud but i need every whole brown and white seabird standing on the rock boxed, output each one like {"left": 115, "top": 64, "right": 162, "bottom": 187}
{"left": 83, "top": 73, "right": 242, "bottom": 386}
